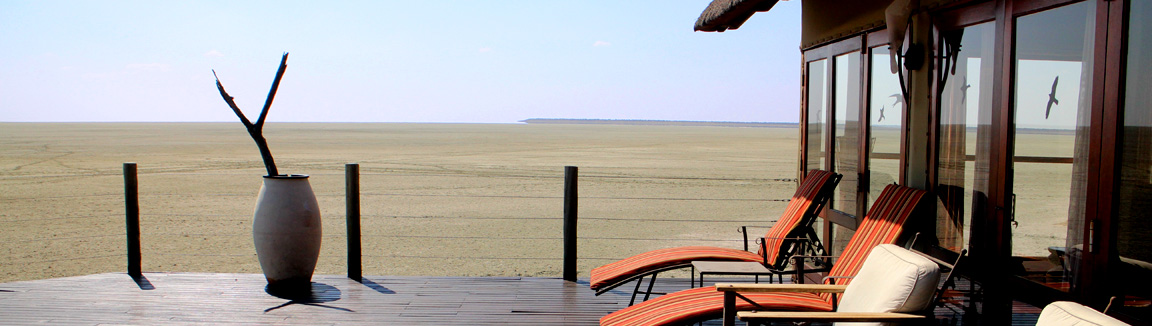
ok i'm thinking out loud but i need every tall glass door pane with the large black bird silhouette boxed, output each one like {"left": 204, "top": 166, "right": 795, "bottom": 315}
{"left": 1010, "top": 1, "right": 1096, "bottom": 290}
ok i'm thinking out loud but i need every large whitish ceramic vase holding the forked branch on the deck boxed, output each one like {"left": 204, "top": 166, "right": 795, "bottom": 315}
{"left": 252, "top": 174, "right": 321, "bottom": 288}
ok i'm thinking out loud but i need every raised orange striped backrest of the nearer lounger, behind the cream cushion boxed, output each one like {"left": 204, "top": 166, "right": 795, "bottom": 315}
{"left": 823, "top": 184, "right": 927, "bottom": 301}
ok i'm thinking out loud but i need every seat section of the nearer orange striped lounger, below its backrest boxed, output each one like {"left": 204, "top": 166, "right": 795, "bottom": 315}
{"left": 600, "top": 287, "right": 832, "bottom": 325}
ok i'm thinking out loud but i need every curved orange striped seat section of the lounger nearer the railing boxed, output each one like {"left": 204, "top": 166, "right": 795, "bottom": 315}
{"left": 591, "top": 245, "right": 761, "bottom": 289}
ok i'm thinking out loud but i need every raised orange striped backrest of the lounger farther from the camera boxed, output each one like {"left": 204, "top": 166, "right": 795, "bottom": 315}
{"left": 759, "top": 169, "right": 833, "bottom": 266}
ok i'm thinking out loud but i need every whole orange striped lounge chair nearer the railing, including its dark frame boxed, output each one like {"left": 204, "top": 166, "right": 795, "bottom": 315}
{"left": 590, "top": 169, "right": 841, "bottom": 301}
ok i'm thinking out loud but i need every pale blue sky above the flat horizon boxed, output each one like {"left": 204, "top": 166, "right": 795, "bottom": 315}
{"left": 0, "top": 0, "right": 801, "bottom": 123}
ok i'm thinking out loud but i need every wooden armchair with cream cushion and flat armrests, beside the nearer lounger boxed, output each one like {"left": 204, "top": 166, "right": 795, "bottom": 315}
{"left": 732, "top": 244, "right": 940, "bottom": 326}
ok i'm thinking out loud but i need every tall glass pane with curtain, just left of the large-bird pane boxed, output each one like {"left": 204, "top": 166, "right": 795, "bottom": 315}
{"left": 935, "top": 23, "right": 995, "bottom": 251}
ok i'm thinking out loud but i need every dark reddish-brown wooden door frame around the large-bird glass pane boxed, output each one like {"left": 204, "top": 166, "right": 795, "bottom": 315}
{"left": 930, "top": 0, "right": 1128, "bottom": 318}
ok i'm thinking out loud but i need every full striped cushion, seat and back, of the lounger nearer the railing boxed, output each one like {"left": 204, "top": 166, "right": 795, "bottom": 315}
{"left": 590, "top": 169, "right": 833, "bottom": 289}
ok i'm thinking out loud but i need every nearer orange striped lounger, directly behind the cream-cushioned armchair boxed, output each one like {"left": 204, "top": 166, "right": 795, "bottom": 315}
{"left": 600, "top": 184, "right": 927, "bottom": 325}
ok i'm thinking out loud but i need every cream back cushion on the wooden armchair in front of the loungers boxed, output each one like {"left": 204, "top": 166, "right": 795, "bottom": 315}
{"left": 836, "top": 244, "right": 940, "bottom": 325}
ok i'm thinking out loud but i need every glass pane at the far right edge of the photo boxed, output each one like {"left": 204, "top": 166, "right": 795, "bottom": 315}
{"left": 1109, "top": 1, "right": 1152, "bottom": 320}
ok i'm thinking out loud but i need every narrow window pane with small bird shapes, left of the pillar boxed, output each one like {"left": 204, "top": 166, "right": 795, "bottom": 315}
{"left": 866, "top": 45, "right": 905, "bottom": 207}
